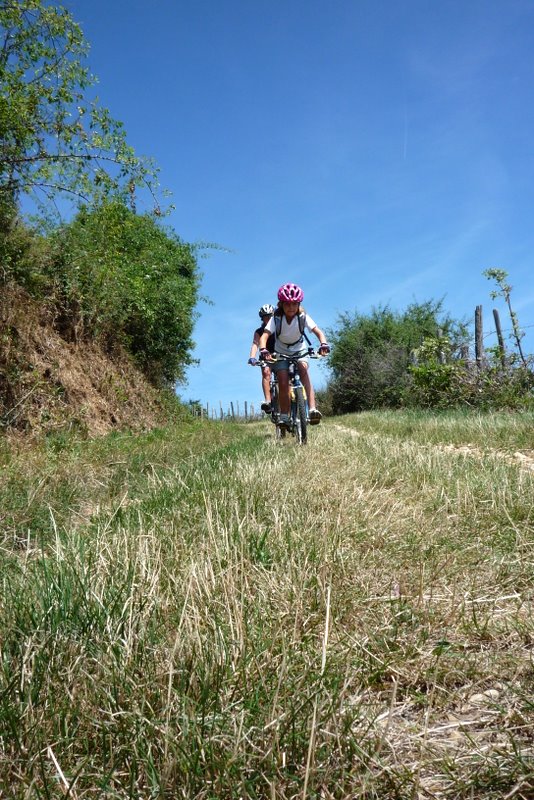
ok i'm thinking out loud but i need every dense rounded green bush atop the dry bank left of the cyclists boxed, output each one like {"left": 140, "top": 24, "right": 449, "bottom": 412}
{"left": 48, "top": 201, "right": 200, "bottom": 384}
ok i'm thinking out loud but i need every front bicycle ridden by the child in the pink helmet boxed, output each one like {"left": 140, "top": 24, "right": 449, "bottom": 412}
{"left": 257, "top": 347, "right": 320, "bottom": 444}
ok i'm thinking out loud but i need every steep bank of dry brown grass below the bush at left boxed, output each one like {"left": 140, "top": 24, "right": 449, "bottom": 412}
{"left": 0, "top": 286, "right": 180, "bottom": 435}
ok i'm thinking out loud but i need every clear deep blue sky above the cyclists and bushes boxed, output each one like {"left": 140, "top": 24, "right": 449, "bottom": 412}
{"left": 65, "top": 0, "right": 534, "bottom": 407}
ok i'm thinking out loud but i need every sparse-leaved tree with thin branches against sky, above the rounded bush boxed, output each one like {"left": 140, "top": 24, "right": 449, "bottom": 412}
{"left": 0, "top": 0, "right": 156, "bottom": 214}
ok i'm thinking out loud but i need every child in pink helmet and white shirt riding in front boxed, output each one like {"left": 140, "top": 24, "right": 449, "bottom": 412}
{"left": 260, "top": 283, "right": 330, "bottom": 427}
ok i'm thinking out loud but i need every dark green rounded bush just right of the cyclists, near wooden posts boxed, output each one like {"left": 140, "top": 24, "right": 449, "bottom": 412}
{"left": 329, "top": 300, "right": 465, "bottom": 413}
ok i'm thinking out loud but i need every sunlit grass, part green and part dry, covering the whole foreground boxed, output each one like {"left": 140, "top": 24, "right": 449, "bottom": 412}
{"left": 0, "top": 412, "right": 534, "bottom": 800}
